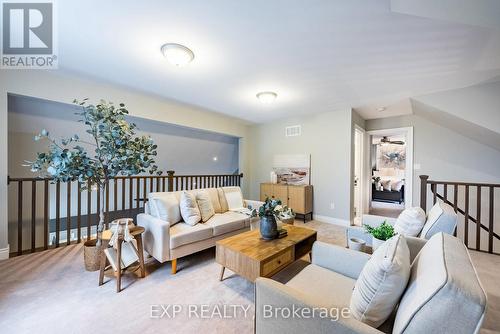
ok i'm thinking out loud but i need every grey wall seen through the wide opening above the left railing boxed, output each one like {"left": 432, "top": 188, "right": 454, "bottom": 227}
{"left": 8, "top": 96, "right": 239, "bottom": 177}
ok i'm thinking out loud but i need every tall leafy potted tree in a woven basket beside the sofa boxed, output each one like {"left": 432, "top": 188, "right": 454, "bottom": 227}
{"left": 27, "top": 99, "right": 161, "bottom": 270}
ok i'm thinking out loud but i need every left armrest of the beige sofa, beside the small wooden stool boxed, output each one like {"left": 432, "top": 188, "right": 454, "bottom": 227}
{"left": 137, "top": 213, "right": 170, "bottom": 263}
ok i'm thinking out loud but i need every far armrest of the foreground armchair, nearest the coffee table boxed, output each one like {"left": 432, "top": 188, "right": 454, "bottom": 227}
{"left": 312, "top": 241, "right": 370, "bottom": 279}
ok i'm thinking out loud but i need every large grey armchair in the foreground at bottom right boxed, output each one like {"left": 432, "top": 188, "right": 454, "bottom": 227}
{"left": 255, "top": 233, "right": 486, "bottom": 334}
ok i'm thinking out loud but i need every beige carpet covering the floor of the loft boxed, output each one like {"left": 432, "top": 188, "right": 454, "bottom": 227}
{"left": 0, "top": 221, "right": 500, "bottom": 334}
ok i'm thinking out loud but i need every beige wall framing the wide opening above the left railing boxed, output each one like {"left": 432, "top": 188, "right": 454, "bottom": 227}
{"left": 0, "top": 70, "right": 254, "bottom": 253}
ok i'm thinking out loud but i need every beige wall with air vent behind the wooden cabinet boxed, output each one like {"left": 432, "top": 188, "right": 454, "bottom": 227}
{"left": 246, "top": 110, "right": 352, "bottom": 224}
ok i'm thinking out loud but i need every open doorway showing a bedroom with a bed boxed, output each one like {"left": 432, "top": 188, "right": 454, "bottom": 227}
{"left": 366, "top": 127, "right": 413, "bottom": 217}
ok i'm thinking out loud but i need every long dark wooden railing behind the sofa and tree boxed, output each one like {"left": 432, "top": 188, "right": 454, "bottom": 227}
{"left": 7, "top": 171, "right": 243, "bottom": 256}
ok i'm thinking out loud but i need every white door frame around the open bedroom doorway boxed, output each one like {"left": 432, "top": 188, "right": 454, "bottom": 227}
{"left": 365, "top": 126, "right": 414, "bottom": 208}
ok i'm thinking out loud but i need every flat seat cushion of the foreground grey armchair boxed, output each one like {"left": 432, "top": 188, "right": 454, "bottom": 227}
{"left": 286, "top": 264, "right": 356, "bottom": 307}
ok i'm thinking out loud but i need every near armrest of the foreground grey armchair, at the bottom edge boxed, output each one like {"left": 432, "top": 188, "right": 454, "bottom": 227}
{"left": 255, "top": 277, "right": 382, "bottom": 334}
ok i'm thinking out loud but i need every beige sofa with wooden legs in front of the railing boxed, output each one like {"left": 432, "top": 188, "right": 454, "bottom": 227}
{"left": 137, "top": 187, "right": 262, "bottom": 274}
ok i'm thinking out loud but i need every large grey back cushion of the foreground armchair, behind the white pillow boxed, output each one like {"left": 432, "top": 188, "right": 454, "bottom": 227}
{"left": 393, "top": 233, "right": 486, "bottom": 333}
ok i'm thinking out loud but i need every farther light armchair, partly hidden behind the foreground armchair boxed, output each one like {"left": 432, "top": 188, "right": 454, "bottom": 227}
{"left": 346, "top": 201, "right": 458, "bottom": 246}
